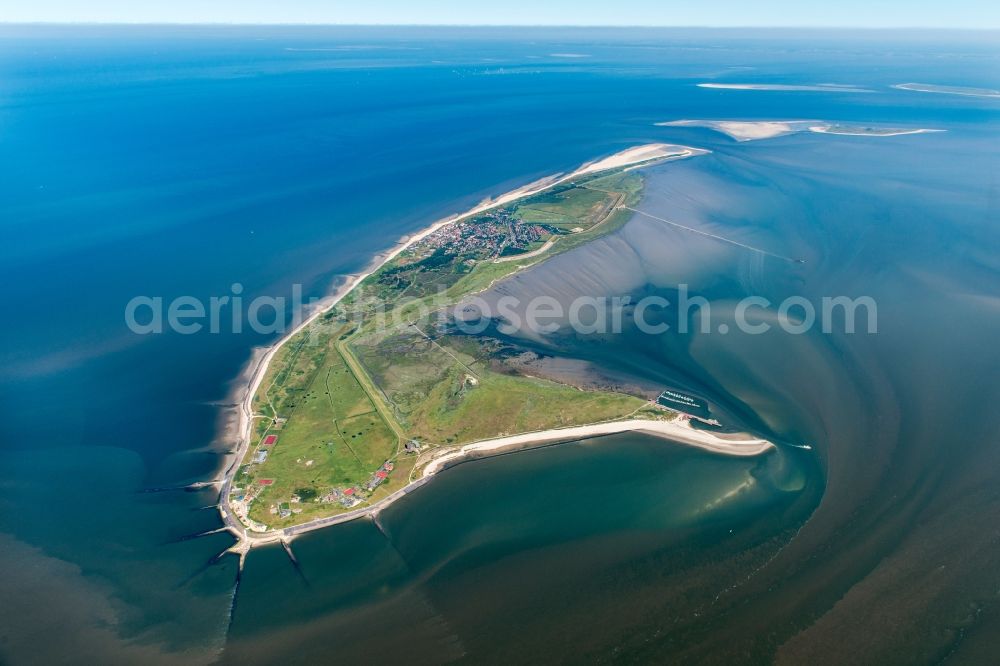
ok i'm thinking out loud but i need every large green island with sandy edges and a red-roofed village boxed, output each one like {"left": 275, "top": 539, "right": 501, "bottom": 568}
{"left": 220, "top": 144, "right": 773, "bottom": 555}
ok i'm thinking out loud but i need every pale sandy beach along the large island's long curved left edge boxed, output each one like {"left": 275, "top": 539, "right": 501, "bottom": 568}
{"left": 214, "top": 143, "right": 710, "bottom": 555}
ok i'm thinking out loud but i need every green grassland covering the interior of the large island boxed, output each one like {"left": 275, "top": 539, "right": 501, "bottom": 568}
{"left": 233, "top": 171, "right": 660, "bottom": 528}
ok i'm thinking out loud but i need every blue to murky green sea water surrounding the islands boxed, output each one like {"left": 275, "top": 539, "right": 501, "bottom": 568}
{"left": 0, "top": 26, "right": 1000, "bottom": 663}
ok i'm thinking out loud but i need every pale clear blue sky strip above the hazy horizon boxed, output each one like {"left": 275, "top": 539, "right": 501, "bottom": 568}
{"left": 7, "top": 0, "right": 1000, "bottom": 28}
